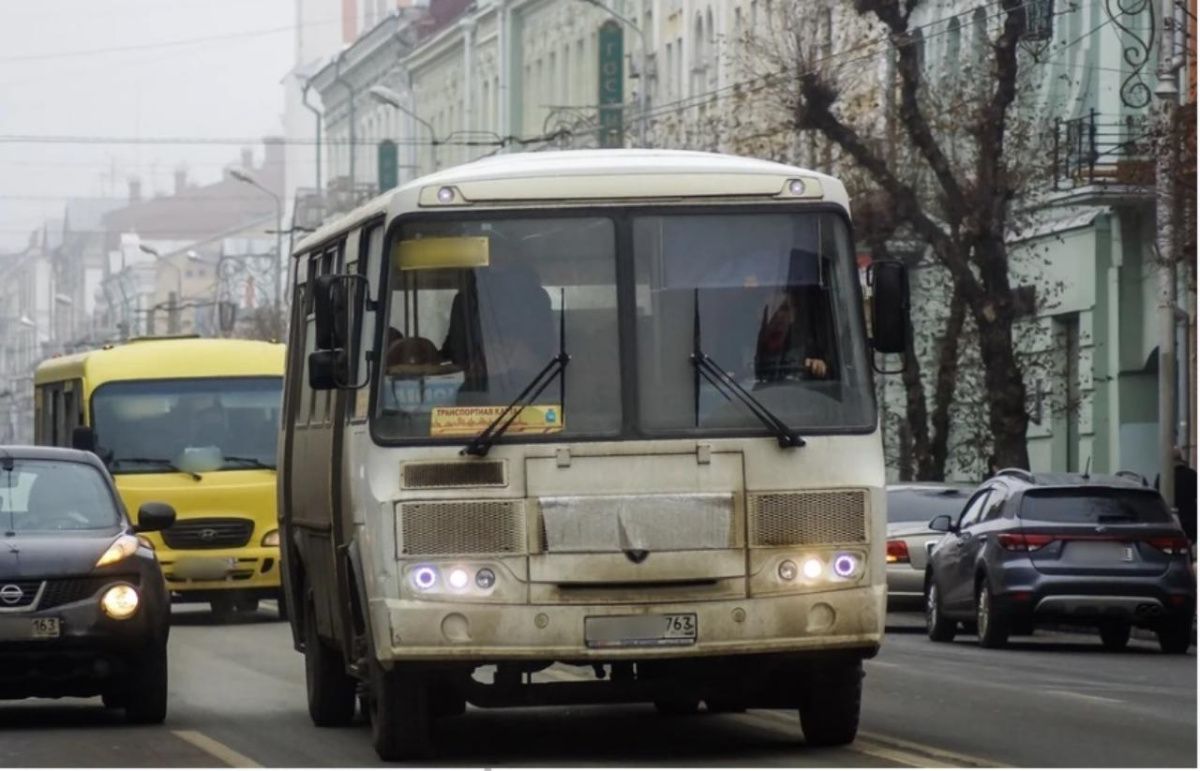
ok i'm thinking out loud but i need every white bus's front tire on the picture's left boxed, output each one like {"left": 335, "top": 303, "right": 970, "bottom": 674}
{"left": 370, "top": 658, "right": 433, "bottom": 763}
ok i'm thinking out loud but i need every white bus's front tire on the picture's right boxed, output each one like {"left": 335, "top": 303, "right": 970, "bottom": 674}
{"left": 799, "top": 659, "right": 863, "bottom": 747}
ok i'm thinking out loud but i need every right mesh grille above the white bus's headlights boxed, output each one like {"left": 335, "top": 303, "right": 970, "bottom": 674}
{"left": 748, "top": 490, "right": 866, "bottom": 546}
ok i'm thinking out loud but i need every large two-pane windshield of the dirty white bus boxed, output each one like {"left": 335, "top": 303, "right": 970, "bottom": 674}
{"left": 376, "top": 211, "right": 875, "bottom": 442}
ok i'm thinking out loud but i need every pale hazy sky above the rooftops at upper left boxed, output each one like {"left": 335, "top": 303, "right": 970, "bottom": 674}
{"left": 0, "top": 0, "right": 314, "bottom": 247}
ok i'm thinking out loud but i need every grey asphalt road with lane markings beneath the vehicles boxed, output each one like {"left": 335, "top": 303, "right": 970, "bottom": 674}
{"left": 0, "top": 606, "right": 1196, "bottom": 767}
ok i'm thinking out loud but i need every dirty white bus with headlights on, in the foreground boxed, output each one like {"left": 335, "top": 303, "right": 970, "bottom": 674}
{"left": 278, "top": 150, "right": 907, "bottom": 760}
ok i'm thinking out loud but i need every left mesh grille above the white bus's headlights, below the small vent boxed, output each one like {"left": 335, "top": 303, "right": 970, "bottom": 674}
{"left": 400, "top": 501, "right": 526, "bottom": 556}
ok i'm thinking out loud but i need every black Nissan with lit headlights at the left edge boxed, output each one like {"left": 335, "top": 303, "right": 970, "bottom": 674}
{"left": 0, "top": 447, "right": 175, "bottom": 723}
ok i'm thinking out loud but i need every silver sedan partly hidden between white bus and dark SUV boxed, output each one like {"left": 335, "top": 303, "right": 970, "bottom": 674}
{"left": 887, "top": 484, "right": 971, "bottom": 600}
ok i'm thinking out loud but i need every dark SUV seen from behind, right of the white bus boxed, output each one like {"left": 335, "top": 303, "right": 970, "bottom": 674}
{"left": 925, "top": 470, "right": 1196, "bottom": 653}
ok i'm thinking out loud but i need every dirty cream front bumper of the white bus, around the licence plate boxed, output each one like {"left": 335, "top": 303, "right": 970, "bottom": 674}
{"left": 370, "top": 584, "right": 887, "bottom": 663}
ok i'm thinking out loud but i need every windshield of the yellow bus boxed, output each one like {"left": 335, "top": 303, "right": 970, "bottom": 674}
{"left": 91, "top": 377, "right": 282, "bottom": 473}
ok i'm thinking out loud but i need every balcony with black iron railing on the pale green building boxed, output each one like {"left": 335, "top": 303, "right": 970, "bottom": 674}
{"left": 1052, "top": 109, "right": 1154, "bottom": 198}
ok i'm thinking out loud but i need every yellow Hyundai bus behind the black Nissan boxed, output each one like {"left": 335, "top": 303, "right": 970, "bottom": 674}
{"left": 34, "top": 337, "right": 286, "bottom": 622}
